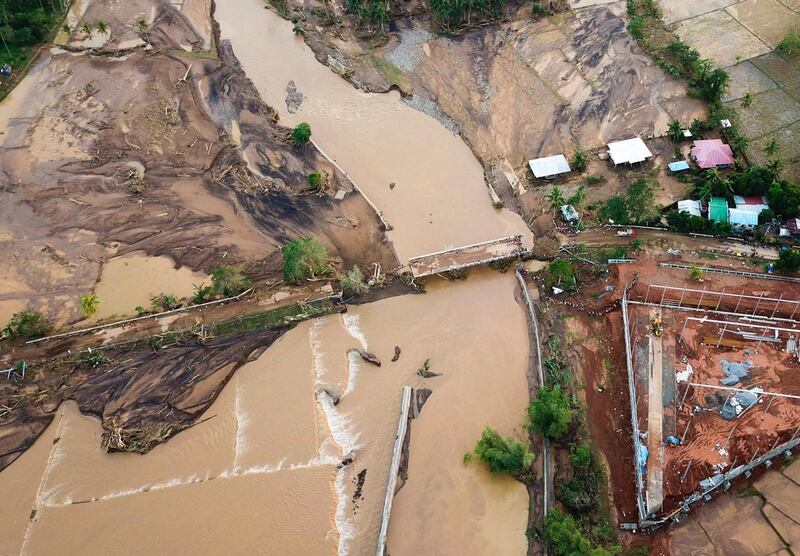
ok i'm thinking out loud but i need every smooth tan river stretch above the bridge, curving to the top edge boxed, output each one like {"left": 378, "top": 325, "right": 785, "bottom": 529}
{"left": 215, "top": 0, "right": 531, "bottom": 261}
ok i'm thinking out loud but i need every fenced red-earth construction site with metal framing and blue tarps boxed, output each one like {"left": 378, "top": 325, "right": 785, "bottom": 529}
{"left": 621, "top": 263, "right": 800, "bottom": 529}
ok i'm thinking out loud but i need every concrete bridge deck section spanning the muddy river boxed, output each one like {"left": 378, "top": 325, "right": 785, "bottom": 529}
{"left": 408, "top": 235, "right": 525, "bottom": 278}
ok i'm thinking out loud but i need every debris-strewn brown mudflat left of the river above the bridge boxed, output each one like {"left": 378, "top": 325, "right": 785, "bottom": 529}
{"left": 0, "top": 2, "right": 394, "bottom": 324}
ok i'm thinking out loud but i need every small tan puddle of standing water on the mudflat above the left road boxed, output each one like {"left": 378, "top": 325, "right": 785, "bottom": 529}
{"left": 95, "top": 253, "right": 211, "bottom": 318}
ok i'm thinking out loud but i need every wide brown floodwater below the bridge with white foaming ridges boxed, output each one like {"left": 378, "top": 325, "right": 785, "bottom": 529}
{"left": 0, "top": 271, "right": 528, "bottom": 555}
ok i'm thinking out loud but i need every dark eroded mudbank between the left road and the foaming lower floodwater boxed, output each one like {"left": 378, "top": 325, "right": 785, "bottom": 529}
{"left": 0, "top": 328, "right": 285, "bottom": 468}
